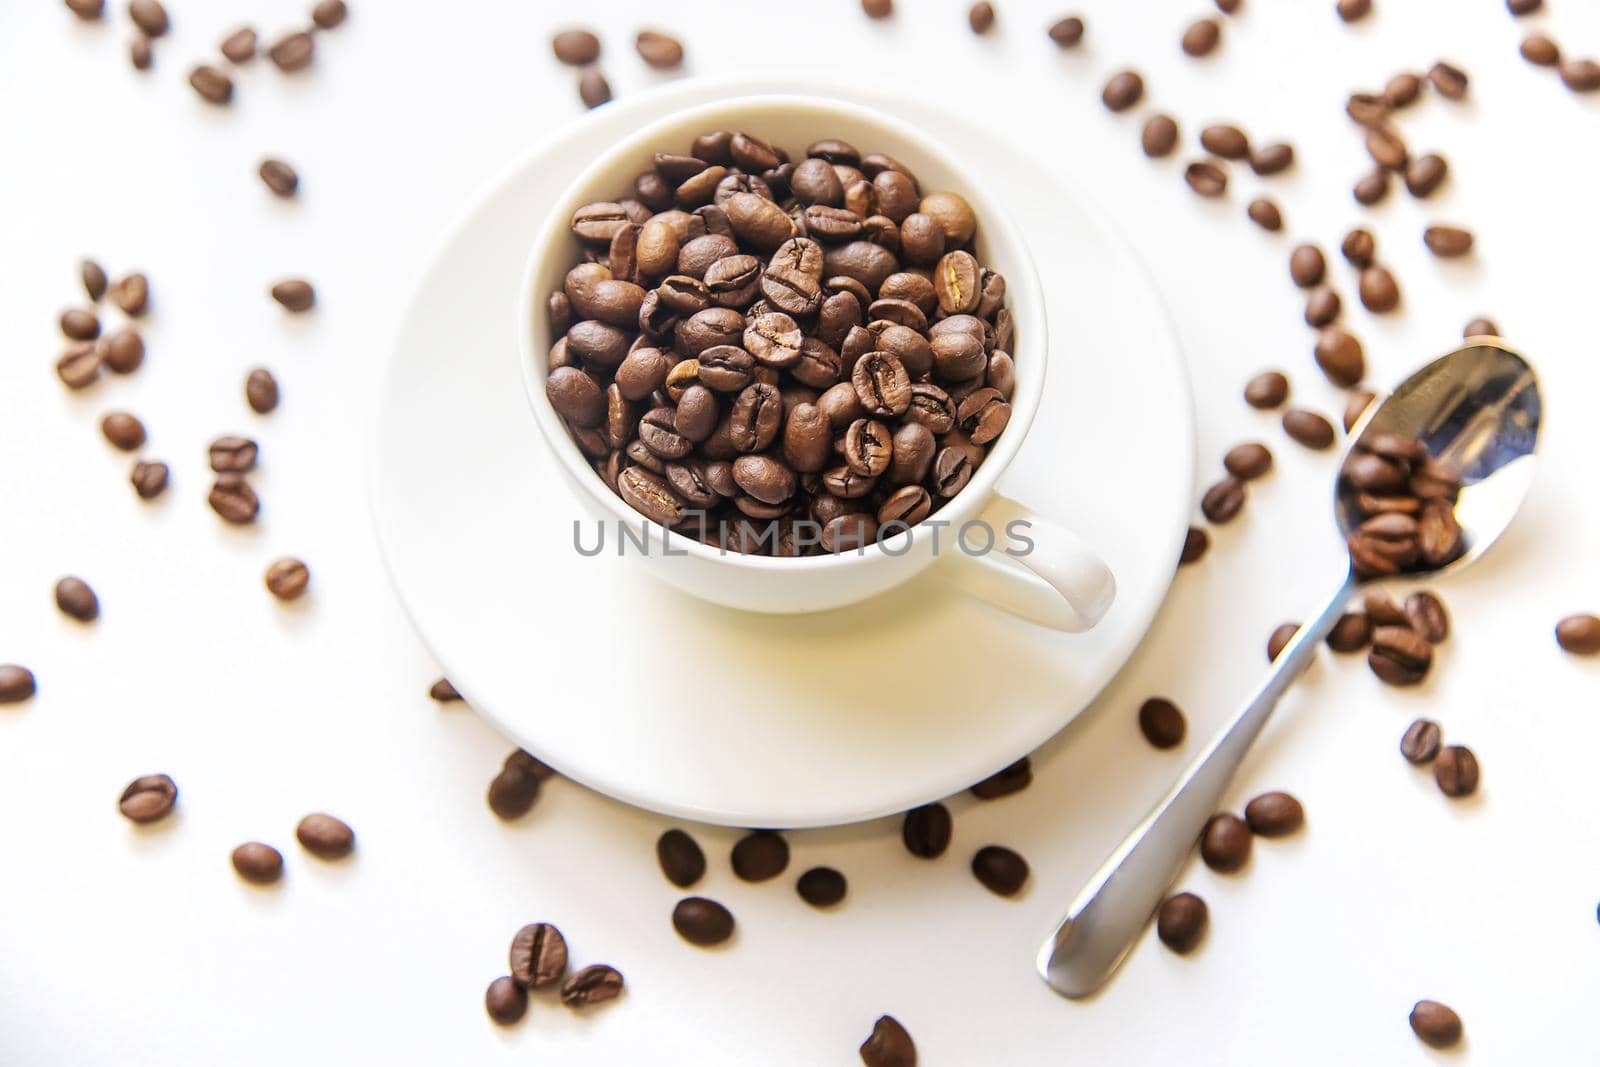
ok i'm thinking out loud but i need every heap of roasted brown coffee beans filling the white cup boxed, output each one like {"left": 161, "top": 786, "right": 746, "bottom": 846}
{"left": 546, "top": 130, "right": 1014, "bottom": 557}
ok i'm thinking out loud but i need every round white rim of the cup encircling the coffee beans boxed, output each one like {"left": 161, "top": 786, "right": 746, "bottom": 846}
{"left": 517, "top": 93, "right": 1050, "bottom": 573}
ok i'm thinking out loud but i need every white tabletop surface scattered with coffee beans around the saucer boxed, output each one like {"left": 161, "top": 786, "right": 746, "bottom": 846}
{"left": 0, "top": 0, "right": 1600, "bottom": 1065}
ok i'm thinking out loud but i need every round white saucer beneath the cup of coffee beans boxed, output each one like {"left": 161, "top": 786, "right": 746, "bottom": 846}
{"left": 371, "top": 80, "right": 1194, "bottom": 827}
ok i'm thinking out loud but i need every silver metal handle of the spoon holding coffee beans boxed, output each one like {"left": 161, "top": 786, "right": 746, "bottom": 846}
{"left": 1037, "top": 576, "right": 1355, "bottom": 998}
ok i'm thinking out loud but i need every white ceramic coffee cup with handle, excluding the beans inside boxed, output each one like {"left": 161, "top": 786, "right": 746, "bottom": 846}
{"left": 517, "top": 96, "right": 1117, "bottom": 632}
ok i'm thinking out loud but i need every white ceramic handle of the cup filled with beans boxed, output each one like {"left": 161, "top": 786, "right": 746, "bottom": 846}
{"left": 936, "top": 494, "right": 1117, "bottom": 633}
